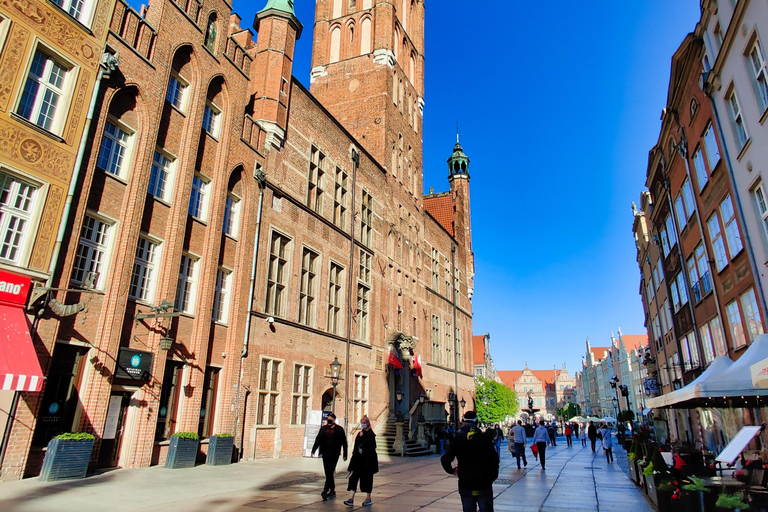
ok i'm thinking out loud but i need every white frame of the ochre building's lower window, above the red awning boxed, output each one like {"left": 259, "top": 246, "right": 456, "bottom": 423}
{"left": 0, "top": 172, "right": 45, "bottom": 265}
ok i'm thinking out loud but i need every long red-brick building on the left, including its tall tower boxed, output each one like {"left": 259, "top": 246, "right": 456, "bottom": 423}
{"left": 2, "top": 0, "right": 474, "bottom": 478}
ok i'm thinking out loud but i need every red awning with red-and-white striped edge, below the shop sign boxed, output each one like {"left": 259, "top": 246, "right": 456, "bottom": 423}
{"left": 0, "top": 304, "right": 43, "bottom": 391}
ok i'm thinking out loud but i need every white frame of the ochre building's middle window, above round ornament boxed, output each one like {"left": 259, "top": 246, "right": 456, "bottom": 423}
{"left": 13, "top": 45, "right": 79, "bottom": 136}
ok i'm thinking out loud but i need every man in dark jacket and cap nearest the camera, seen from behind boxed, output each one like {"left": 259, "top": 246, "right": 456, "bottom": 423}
{"left": 440, "top": 411, "right": 499, "bottom": 512}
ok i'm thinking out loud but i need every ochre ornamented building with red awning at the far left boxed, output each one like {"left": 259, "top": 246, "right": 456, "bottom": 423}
{"left": 0, "top": 0, "right": 114, "bottom": 478}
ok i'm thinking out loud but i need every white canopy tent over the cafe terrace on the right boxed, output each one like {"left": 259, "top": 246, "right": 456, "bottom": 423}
{"left": 647, "top": 334, "right": 768, "bottom": 409}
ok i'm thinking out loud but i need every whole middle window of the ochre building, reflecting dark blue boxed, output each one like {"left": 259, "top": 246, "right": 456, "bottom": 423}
{"left": 16, "top": 50, "right": 70, "bottom": 133}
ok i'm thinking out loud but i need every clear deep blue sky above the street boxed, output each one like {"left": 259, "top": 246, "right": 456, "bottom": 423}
{"left": 135, "top": 0, "right": 699, "bottom": 372}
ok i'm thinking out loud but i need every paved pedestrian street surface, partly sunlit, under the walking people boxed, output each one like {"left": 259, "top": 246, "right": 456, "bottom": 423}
{"left": 0, "top": 439, "right": 653, "bottom": 512}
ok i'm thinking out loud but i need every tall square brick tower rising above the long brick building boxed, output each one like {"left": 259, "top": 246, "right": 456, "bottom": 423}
{"left": 310, "top": 0, "right": 424, "bottom": 197}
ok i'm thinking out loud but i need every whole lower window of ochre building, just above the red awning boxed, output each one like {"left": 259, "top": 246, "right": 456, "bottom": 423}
{"left": 0, "top": 172, "right": 37, "bottom": 263}
